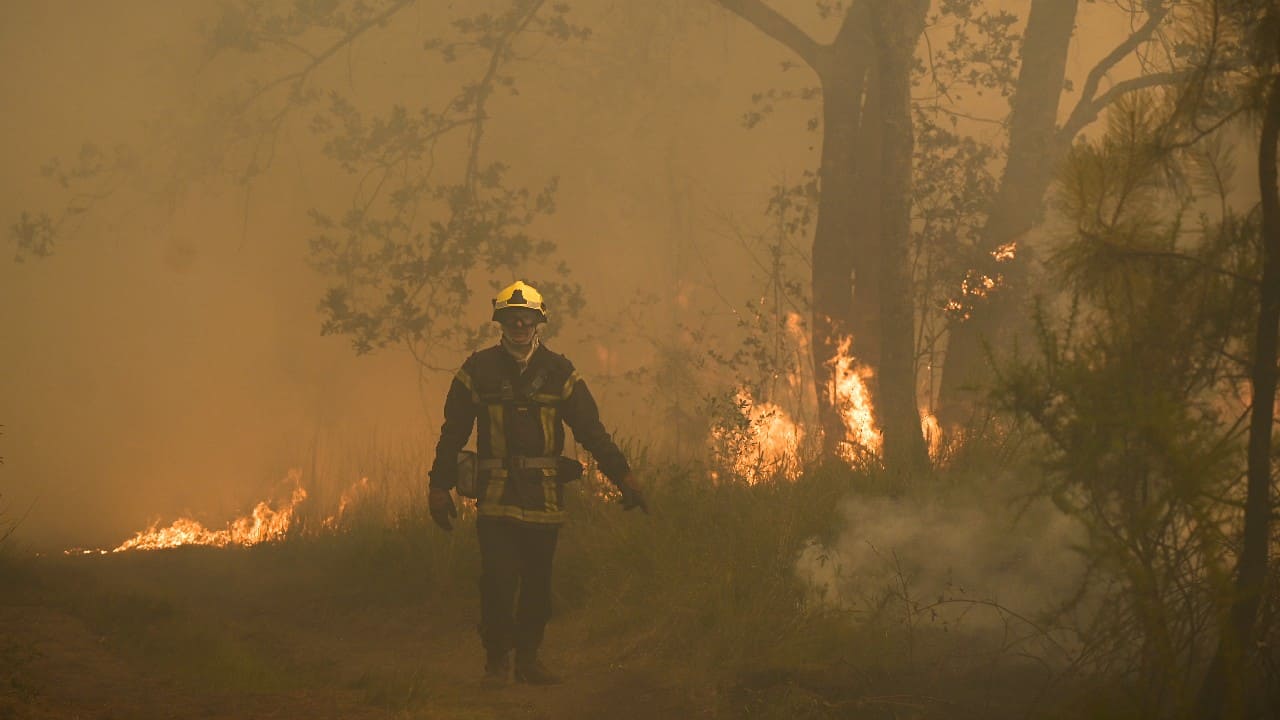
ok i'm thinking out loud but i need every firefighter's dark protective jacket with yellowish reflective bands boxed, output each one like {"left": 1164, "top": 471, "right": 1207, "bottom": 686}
{"left": 431, "top": 345, "right": 628, "bottom": 525}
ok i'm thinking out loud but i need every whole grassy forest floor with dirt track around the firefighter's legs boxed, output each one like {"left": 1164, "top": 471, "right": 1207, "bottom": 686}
{"left": 0, "top": 473, "right": 1090, "bottom": 720}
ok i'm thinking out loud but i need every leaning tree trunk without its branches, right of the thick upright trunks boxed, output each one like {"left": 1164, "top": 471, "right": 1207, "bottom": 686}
{"left": 938, "top": 0, "right": 1078, "bottom": 428}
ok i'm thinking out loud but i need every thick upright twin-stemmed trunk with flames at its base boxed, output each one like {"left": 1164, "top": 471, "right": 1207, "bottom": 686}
{"left": 719, "top": 0, "right": 928, "bottom": 468}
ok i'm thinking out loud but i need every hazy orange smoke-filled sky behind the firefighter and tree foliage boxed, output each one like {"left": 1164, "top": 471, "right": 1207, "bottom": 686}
{"left": 0, "top": 0, "right": 1157, "bottom": 547}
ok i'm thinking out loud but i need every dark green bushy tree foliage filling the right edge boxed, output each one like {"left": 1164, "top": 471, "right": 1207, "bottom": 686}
{"left": 997, "top": 0, "right": 1280, "bottom": 717}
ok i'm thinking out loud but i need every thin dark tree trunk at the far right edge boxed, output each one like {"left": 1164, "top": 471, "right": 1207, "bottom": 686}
{"left": 1197, "top": 70, "right": 1280, "bottom": 717}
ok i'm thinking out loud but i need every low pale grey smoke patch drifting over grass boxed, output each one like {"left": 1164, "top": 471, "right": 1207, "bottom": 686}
{"left": 796, "top": 486, "right": 1083, "bottom": 626}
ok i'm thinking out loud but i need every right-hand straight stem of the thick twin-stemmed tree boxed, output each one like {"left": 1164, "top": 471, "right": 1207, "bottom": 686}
{"left": 872, "top": 0, "right": 929, "bottom": 477}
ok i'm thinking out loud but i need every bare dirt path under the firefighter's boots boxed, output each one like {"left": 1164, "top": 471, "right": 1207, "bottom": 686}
{"left": 0, "top": 586, "right": 708, "bottom": 720}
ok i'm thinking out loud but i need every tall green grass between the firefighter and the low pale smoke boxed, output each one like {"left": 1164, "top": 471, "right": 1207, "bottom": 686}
{"left": 557, "top": 458, "right": 849, "bottom": 674}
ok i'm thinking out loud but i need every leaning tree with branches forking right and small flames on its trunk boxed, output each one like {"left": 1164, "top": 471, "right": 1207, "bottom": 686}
{"left": 938, "top": 0, "right": 1181, "bottom": 427}
